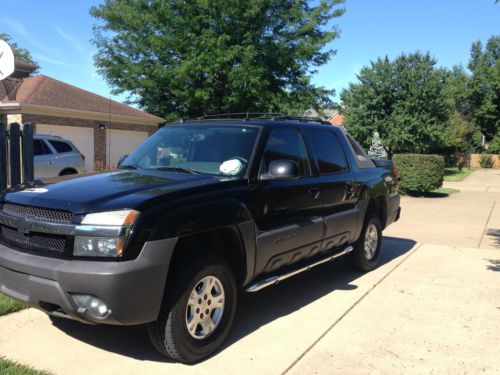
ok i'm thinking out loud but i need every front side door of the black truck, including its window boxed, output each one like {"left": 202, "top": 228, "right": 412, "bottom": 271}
{"left": 256, "top": 129, "right": 323, "bottom": 274}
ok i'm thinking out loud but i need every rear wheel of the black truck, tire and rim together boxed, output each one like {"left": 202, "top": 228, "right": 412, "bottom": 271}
{"left": 346, "top": 212, "right": 382, "bottom": 271}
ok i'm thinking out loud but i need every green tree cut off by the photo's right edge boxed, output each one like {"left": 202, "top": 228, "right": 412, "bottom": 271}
{"left": 468, "top": 35, "right": 500, "bottom": 141}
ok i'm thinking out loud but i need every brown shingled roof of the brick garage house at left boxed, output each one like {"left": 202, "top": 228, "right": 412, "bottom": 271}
{"left": 0, "top": 74, "right": 165, "bottom": 123}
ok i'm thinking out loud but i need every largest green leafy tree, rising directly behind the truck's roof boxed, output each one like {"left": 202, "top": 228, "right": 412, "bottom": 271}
{"left": 90, "top": 0, "right": 343, "bottom": 120}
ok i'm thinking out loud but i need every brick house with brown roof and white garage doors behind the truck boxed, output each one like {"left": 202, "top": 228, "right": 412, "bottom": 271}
{"left": 0, "top": 62, "right": 165, "bottom": 171}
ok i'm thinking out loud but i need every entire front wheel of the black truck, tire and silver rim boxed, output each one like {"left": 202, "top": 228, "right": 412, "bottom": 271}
{"left": 148, "top": 258, "right": 237, "bottom": 363}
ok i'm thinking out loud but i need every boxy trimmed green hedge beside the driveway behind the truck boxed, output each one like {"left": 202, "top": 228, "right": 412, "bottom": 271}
{"left": 393, "top": 154, "right": 444, "bottom": 195}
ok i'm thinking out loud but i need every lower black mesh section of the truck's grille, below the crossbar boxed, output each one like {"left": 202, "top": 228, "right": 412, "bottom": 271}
{"left": 0, "top": 225, "right": 68, "bottom": 256}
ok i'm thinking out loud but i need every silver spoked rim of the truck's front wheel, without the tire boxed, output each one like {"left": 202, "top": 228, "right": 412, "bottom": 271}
{"left": 186, "top": 276, "right": 225, "bottom": 340}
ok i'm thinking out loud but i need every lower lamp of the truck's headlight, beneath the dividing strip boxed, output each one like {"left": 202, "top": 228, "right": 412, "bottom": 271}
{"left": 73, "top": 236, "right": 125, "bottom": 257}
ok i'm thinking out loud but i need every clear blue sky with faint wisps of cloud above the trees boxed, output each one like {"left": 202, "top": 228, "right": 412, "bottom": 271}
{"left": 0, "top": 0, "right": 500, "bottom": 105}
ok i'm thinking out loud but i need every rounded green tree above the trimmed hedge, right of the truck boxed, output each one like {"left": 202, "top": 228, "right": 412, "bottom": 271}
{"left": 341, "top": 52, "right": 453, "bottom": 158}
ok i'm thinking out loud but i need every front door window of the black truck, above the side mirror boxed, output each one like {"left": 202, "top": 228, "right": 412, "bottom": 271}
{"left": 262, "top": 129, "right": 311, "bottom": 176}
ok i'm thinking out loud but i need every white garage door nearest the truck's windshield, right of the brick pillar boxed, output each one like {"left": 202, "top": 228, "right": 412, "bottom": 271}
{"left": 107, "top": 130, "right": 148, "bottom": 169}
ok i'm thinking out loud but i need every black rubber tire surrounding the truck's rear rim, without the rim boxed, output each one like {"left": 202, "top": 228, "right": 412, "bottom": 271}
{"left": 346, "top": 212, "right": 382, "bottom": 272}
